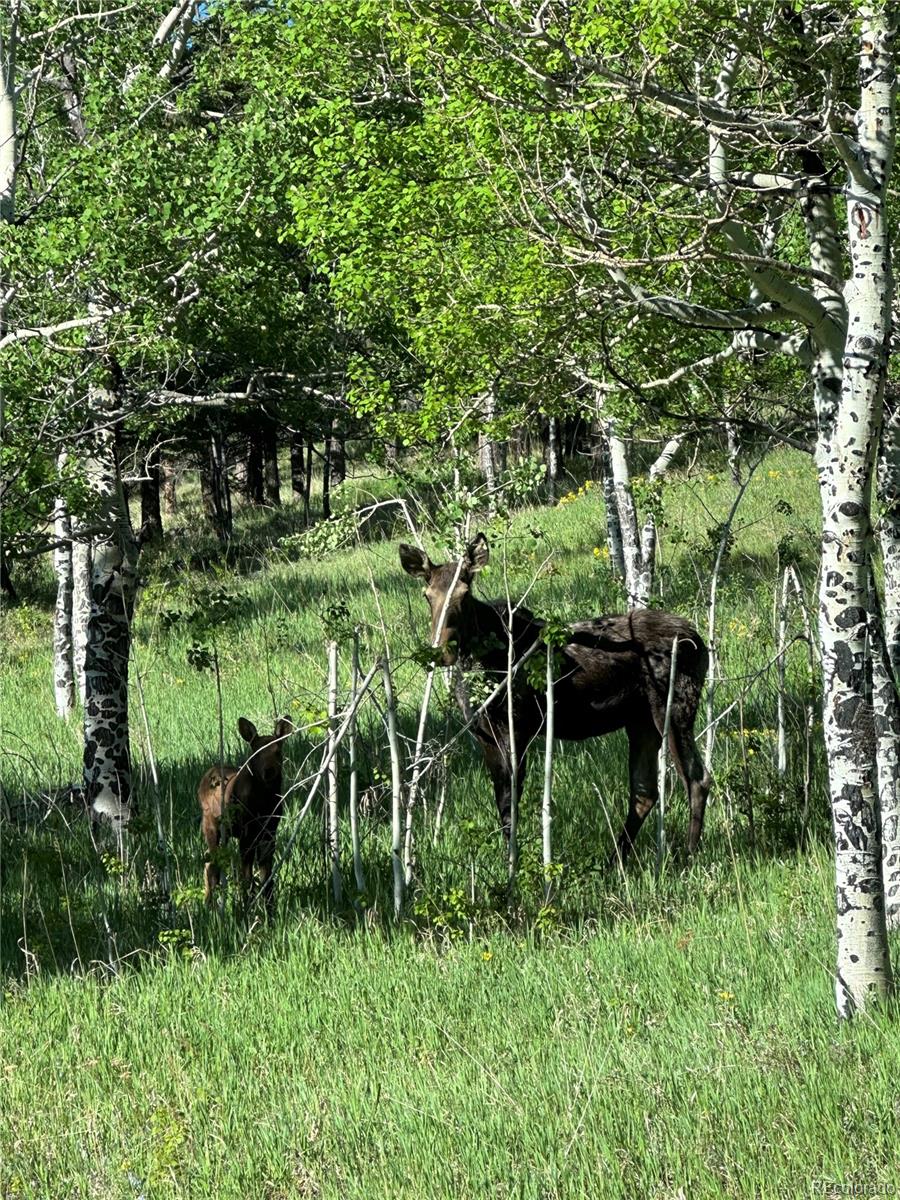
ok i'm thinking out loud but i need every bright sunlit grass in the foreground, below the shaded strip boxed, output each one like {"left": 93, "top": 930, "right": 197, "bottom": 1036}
{"left": 0, "top": 854, "right": 900, "bottom": 1200}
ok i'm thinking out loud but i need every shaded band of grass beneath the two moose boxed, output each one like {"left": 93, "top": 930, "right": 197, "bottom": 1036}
{"left": 0, "top": 700, "right": 826, "bottom": 979}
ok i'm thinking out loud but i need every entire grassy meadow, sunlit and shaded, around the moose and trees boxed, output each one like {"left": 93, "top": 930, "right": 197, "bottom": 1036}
{"left": 0, "top": 452, "right": 900, "bottom": 1200}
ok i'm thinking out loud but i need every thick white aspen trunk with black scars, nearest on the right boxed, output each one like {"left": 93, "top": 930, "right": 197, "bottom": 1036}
{"left": 820, "top": 11, "right": 895, "bottom": 1016}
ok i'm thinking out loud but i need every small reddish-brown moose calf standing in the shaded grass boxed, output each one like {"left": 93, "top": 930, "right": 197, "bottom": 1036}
{"left": 197, "top": 716, "right": 293, "bottom": 911}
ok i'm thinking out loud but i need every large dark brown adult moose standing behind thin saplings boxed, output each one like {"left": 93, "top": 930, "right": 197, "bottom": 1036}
{"left": 400, "top": 533, "right": 710, "bottom": 863}
